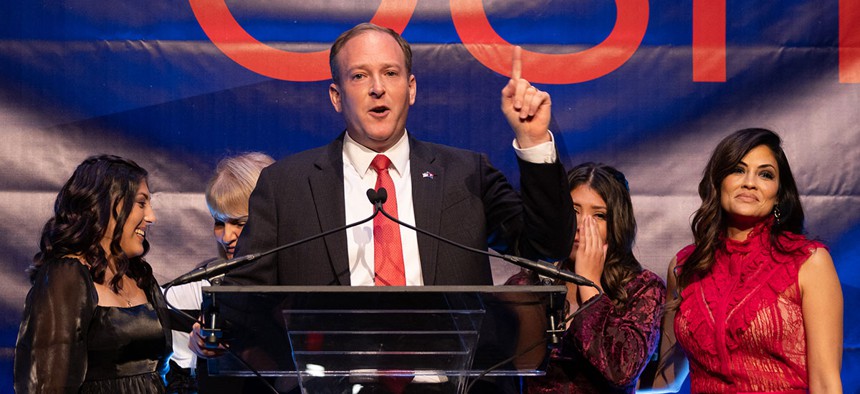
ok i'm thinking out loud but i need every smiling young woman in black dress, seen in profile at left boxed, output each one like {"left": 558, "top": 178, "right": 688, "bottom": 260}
{"left": 14, "top": 155, "right": 171, "bottom": 393}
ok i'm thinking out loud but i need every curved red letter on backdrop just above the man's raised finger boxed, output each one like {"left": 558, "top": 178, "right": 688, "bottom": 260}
{"left": 450, "top": 0, "right": 648, "bottom": 84}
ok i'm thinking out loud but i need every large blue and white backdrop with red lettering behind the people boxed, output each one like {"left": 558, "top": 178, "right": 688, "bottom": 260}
{"left": 0, "top": 0, "right": 860, "bottom": 392}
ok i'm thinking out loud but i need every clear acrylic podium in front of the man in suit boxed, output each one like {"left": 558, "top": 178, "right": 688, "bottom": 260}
{"left": 203, "top": 286, "right": 566, "bottom": 392}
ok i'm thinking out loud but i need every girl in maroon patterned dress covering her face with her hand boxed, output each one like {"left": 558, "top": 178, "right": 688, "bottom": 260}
{"left": 508, "top": 163, "right": 666, "bottom": 393}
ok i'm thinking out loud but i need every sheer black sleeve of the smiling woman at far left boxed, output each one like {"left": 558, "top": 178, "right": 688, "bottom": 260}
{"left": 14, "top": 259, "right": 98, "bottom": 393}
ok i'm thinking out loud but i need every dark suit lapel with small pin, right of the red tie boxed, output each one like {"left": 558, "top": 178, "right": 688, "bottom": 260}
{"left": 409, "top": 134, "right": 445, "bottom": 285}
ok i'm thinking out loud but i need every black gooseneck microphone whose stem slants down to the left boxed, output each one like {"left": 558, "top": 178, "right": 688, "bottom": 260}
{"left": 162, "top": 188, "right": 388, "bottom": 289}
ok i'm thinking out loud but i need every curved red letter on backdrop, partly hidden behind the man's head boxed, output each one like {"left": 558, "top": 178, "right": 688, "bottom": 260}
{"left": 189, "top": 0, "right": 418, "bottom": 82}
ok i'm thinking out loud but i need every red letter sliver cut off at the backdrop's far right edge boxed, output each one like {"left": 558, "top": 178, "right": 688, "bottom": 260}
{"left": 839, "top": 0, "right": 860, "bottom": 83}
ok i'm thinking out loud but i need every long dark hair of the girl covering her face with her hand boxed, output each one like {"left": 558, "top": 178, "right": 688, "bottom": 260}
{"left": 567, "top": 162, "right": 642, "bottom": 307}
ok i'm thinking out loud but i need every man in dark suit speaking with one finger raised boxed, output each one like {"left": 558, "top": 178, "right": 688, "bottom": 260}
{"left": 218, "top": 24, "right": 575, "bottom": 286}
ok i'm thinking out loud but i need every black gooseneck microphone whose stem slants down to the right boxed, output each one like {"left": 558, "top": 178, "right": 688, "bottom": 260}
{"left": 367, "top": 187, "right": 600, "bottom": 292}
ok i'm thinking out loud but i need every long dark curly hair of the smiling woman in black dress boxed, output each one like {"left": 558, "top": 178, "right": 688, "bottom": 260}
{"left": 28, "top": 155, "right": 152, "bottom": 291}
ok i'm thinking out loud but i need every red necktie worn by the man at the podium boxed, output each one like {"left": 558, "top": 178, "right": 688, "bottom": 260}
{"left": 370, "top": 155, "right": 406, "bottom": 286}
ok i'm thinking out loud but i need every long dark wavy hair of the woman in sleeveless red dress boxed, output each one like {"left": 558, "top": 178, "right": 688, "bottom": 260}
{"left": 677, "top": 128, "right": 804, "bottom": 294}
